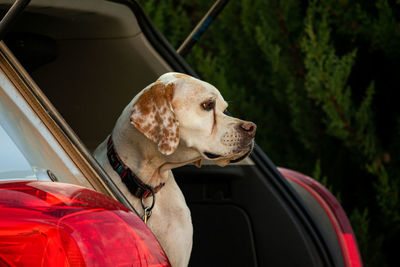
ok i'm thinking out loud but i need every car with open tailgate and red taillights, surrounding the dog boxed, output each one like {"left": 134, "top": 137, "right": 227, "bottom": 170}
{"left": 0, "top": 0, "right": 362, "bottom": 267}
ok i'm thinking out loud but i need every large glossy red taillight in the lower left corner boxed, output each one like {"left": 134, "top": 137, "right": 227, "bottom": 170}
{"left": 0, "top": 182, "right": 169, "bottom": 266}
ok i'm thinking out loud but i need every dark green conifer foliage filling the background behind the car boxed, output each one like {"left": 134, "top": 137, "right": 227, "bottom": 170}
{"left": 142, "top": 0, "right": 400, "bottom": 266}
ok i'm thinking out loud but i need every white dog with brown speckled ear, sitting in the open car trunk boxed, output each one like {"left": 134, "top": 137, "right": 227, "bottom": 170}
{"left": 94, "top": 72, "right": 257, "bottom": 267}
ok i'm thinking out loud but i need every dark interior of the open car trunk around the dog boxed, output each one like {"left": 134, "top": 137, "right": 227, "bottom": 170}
{"left": 0, "top": 0, "right": 344, "bottom": 266}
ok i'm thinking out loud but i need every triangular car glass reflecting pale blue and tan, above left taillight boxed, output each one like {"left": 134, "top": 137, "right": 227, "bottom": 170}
{"left": 0, "top": 66, "right": 92, "bottom": 188}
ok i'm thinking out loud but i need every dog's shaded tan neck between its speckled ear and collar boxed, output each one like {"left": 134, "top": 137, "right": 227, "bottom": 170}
{"left": 112, "top": 105, "right": 201, "bottom": 187}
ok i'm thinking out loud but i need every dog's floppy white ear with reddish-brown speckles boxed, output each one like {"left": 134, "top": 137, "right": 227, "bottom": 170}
{"left": 130, "top": 82, "right": 179, "bottom": 155}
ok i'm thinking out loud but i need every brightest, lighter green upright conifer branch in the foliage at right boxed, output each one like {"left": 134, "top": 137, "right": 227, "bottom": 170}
{"left": 302, "top": 1, "right": 377, "bottom": 159}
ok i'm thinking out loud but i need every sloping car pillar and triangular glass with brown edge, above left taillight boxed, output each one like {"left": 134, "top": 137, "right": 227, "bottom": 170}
{"left": 0, "top": 39, "right": 130, "bottom": 207}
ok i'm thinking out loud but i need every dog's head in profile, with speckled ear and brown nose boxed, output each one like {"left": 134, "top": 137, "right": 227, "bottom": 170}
{"left": 130, "top": 73, "right": 257, "bottom": 165}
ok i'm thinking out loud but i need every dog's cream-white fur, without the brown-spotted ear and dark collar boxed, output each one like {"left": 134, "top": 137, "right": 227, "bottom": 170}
{"left": 94, "top": 73, "right": 255, "bottom": 267}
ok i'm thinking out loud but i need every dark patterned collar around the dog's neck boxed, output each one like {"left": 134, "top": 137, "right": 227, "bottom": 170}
{"left": 107, "top": 134, "right": 165, "bottom": 199}
